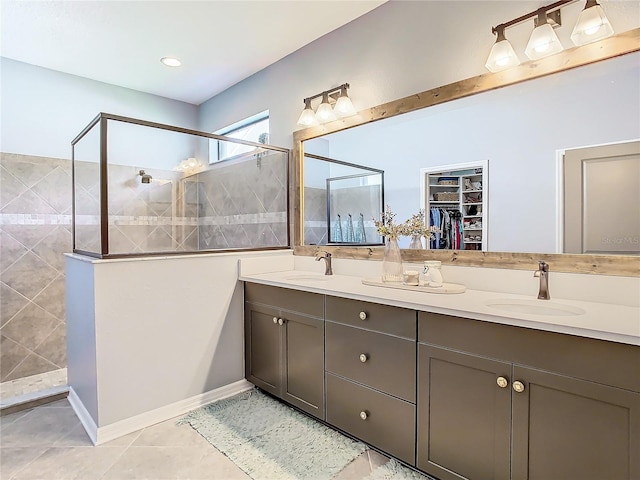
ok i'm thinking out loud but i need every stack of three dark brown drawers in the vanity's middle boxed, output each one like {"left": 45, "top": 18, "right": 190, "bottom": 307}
{"left": 325, "top": 296, "right": 417, "bottom": 465}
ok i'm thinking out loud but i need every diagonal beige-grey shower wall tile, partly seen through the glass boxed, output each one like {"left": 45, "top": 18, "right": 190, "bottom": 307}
{"left": 0, "top": 153, "right": 287, "bottom": 388}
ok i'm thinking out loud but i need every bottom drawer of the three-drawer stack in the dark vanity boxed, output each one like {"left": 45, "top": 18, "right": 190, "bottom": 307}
{"left": 327, "top": 374, "right": 416, "bottom": 465}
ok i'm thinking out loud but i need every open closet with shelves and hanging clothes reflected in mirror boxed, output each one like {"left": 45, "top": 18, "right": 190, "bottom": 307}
{"left": 423, "top": 164, "right": 487, "bottom": 250}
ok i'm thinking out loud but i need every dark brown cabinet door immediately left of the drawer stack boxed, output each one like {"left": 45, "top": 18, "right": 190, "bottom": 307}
{"left": 281, "top": 312, "right": 324, "bottom": 419}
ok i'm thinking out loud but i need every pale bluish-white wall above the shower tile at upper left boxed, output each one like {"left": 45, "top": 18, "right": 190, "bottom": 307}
{"left": 0, "top": 58, "right": 197, "bottom": 163}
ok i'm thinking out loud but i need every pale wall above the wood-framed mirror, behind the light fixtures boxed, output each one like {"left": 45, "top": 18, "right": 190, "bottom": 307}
{"left": 199, "top": 0, "right": 640, "bottom": 147}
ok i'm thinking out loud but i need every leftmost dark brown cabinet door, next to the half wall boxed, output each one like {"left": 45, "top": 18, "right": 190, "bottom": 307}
{"left": 244, "top": 303, "right": 282, "bottom": 396}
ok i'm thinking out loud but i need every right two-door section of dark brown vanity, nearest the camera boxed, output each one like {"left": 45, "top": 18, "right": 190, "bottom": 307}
{"left": 417, "top": 312, "right": 640, "bottom": 480}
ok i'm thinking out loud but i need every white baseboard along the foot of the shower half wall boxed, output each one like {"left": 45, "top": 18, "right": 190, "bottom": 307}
{"left": 69, "top": 379, "right": 253, "bottom": 445}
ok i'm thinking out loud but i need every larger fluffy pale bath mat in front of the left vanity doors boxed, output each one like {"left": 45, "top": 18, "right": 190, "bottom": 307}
{"left": 179, "top": 390, "right": 366, "bottom": 480}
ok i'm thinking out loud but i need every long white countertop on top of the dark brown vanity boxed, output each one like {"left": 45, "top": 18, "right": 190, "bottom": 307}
{"left": 239, "top": 270, "right": 640, "bottom": 345}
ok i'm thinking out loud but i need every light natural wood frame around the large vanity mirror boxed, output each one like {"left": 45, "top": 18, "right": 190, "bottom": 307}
{"left": 291, "top": 29, "right": 640, "bottom": 276}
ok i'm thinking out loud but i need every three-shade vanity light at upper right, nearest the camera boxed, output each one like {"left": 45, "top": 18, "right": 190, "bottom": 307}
{"left": 485, "top": 0, "right": 613, "bottom": 72}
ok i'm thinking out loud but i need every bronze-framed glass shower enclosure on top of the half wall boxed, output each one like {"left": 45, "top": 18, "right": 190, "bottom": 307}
{"left": 73, "top": 114, "right": 289, "bottom": 258}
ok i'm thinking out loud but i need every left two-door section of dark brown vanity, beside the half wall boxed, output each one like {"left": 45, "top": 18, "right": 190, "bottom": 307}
{"left": 244, "top": 283, "right": 324, "bottom": 419}
